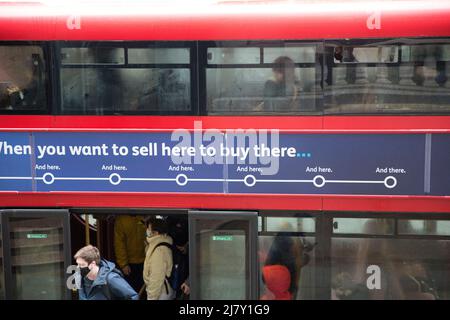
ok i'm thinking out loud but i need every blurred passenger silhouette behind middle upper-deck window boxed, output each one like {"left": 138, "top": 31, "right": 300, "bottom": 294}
{"left": 264, "top": 57, "right": 300, "bottom": 111}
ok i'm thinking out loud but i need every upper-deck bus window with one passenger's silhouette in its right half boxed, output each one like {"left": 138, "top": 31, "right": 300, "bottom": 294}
{"left": 206, "top": 43, "right": 320, "bottom": 114}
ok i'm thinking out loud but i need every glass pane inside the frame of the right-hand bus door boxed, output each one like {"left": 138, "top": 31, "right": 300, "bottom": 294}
{"left": 195, "top": 219, "right": 249, "bottom": 300}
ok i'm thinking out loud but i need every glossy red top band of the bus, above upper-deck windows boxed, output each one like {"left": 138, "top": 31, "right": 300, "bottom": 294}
{"left": 0, "top": 0, "right": 450, "bottom": 41}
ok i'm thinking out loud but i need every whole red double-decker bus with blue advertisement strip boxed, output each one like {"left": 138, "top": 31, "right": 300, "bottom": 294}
{"left": 0, "top": 0, "right": 450, "bottom": 300}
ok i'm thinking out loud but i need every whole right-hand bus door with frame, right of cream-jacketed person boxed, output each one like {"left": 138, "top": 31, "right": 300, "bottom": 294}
{"left": 188, "top": 211, "right": 258, "bottom": 300}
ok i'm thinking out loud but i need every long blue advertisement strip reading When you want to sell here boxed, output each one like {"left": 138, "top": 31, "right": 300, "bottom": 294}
{"left": 0, "top": 130, "right": 450, "bottom": 195}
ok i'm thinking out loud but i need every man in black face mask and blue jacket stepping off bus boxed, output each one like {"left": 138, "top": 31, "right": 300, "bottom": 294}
{"left": 74, "top": 245, "right": 138, "bottom": 300}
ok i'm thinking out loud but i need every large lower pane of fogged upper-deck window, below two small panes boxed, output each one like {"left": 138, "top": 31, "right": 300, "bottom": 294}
{"left": 61, "top": 68, "right": 191, "bottom": 114}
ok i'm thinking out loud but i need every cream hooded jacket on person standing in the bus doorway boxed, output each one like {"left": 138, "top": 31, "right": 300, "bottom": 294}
{"left": 143, "top": 234, "right": 173, "bottom": 300}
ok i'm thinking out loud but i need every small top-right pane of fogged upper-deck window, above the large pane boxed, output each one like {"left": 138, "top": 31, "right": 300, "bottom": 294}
{"left": 128, "top": 48, "right": 190, "bottom": 64}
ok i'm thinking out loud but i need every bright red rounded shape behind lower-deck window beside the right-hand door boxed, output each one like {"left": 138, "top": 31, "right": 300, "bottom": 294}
{"left": 261, "top": 265, "right": 292, "bottom": 300}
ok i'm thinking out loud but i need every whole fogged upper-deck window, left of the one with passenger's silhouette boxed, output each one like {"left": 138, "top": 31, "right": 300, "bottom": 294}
{"left": 61, "top": 47, "right": 192, "bottom": 114}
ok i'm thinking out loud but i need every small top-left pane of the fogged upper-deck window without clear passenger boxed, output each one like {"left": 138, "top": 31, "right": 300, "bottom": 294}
{"left": 61, "top": 47, "right": 125, "bottom": 64}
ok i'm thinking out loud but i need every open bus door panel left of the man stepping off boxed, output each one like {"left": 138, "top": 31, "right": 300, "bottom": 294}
{"left": 0, "top": 209, "right": 71, "bottom": 300}
